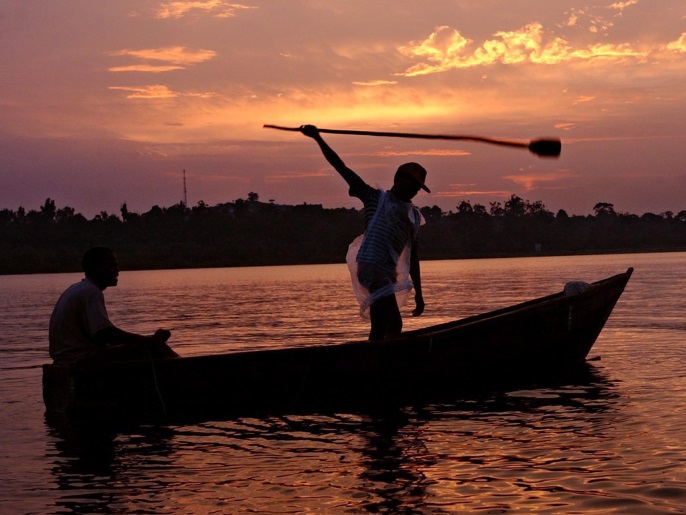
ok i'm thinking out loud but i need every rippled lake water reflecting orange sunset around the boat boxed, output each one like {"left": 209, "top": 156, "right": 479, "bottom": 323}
{"left": 0, "top": 253, "right": 686, "bottom": 515}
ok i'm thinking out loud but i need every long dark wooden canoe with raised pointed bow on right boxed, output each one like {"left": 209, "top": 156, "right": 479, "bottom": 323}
{"left": 43, "top": 268, "right": 633, "bottom": 422}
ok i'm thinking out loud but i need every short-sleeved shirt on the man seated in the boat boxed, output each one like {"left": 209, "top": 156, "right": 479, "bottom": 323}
{"left": 49, "top": 278, "right": 113, "bottom": 364}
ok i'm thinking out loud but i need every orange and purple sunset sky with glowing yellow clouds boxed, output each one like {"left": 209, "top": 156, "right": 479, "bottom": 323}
{"left": 0, "top": 0, "right": 686, "bottom": 218}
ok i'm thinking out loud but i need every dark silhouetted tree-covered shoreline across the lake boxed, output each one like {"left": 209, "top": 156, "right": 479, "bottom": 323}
{"left": 0, "top": 192, "right": 686, "bottom": 274}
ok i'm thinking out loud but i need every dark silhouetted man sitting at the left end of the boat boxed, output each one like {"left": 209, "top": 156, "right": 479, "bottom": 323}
{"left": 49, "top": 247, "right": 178, "bottom": 367}
